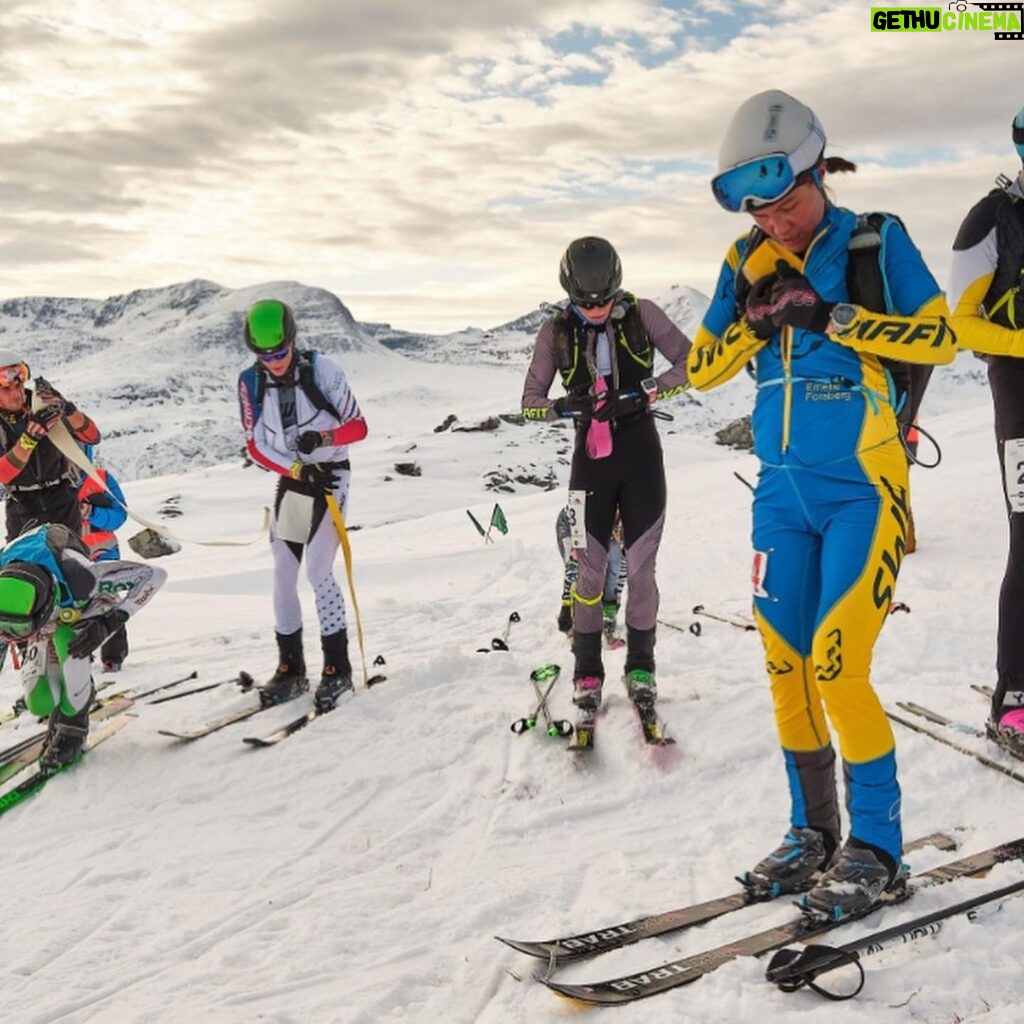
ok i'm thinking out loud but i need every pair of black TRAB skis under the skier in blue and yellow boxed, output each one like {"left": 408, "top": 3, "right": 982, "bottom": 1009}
{"left": 499, "top": 836, "right": 1024, "bottom": 1006}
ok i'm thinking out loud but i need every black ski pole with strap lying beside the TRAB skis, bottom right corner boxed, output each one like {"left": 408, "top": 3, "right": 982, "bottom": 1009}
{"left": 765, "top": 880, "right": 1024, "bottom": 1001}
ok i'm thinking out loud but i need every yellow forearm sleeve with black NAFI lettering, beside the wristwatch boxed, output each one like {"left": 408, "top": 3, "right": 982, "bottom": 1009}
{"left": 828, "top": 295, "right": 956, "bottom": 366}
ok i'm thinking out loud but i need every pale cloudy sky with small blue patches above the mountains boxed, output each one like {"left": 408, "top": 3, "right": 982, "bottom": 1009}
{"left": 0, "top": 0, "right": 1024, "bottom": 331}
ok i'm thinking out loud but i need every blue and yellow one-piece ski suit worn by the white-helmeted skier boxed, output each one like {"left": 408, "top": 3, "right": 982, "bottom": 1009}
{"left": 688, "top": 206, "right": 955, "bottom": 861}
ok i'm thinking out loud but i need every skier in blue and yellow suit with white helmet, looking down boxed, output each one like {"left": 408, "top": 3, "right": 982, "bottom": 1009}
{"left": 688, "top": 90, "right": 955, "bottom": 918}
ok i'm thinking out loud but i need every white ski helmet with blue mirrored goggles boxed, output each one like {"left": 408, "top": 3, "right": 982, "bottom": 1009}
{"left": 712, "top": 89, "right": 825, "bottom": 213}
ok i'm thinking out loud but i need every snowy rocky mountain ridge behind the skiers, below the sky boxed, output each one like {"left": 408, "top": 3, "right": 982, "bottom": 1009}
{"left": 0, "top": 279, "right": 983, "bottom": 486}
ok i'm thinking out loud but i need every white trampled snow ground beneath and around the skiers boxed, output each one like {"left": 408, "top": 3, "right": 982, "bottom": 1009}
{"left": 0, "top": 353, "right": 1024, "bottom": 1024}
